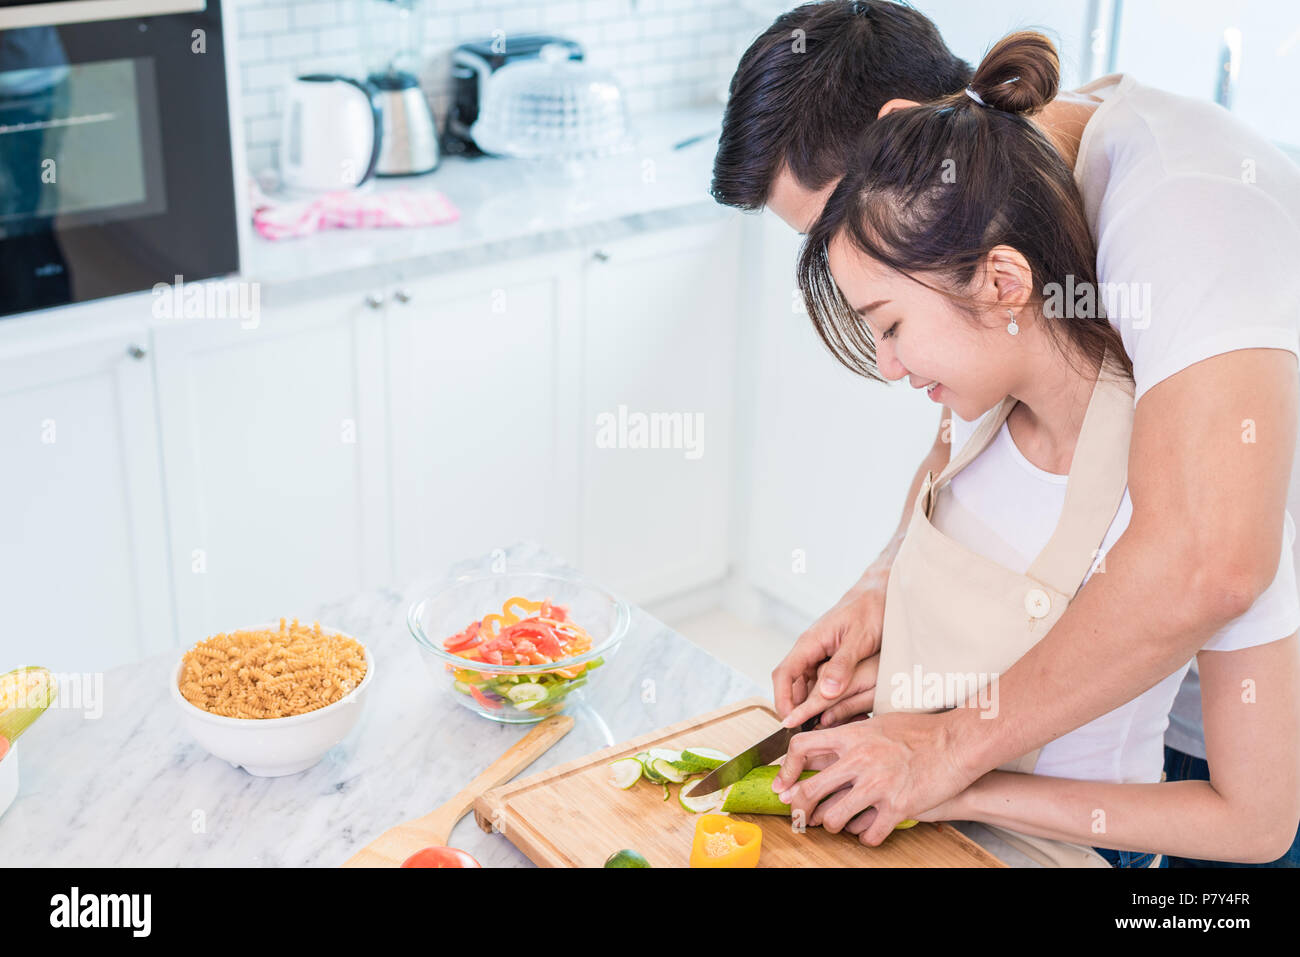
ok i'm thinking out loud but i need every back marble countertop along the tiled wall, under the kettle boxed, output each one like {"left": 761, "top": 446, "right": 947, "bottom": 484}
{"left": 242, "top": 104, "right": 736, "bottom": 299}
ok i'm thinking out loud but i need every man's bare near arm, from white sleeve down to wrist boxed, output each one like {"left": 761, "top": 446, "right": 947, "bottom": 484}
{"left": 943, "top": 350, "right": 1300, "bottom": 779}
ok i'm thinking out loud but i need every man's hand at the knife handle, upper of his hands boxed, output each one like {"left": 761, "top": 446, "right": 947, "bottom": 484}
{"left": 772, "top": 576, "right": 885, "bottom": 727}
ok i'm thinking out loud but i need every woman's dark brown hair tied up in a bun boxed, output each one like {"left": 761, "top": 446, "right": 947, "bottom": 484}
{"left": 798, "top": 31, "right": 1132, "bottom": 381}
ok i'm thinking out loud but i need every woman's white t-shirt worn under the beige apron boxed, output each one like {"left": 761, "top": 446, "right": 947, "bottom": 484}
{"left": 931, "top": 412, "right": 1300, "bottom": 781}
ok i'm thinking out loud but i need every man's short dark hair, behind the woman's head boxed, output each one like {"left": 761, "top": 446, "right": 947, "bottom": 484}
{"left": 711, "top": 0, "right": 971, "bottom": 209}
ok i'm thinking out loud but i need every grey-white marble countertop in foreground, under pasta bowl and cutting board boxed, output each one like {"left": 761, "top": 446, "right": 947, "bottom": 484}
{"left": 0, "top": 544, "right": 767, "bottom": 867}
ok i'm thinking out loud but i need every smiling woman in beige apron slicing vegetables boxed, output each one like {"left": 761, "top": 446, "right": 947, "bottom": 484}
{"left": 800, "top": 34, "right": 1300, "bottom": 866}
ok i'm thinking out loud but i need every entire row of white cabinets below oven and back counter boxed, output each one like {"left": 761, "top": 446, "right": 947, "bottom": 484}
{"left": 0, "top": 217, "right": 740, "bottom": 670}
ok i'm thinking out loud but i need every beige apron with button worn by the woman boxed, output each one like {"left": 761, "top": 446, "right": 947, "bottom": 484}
{"left": 875, "top": 353, "right": 1158, "bottom": 867}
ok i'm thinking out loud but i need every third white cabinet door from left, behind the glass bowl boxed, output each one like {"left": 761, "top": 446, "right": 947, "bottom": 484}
{"left": 386, "top": 252, "right": 581, "bottom": 581}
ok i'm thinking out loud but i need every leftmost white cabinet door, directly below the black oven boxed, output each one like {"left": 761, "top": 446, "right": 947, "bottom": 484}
{"left": 0, "top": 320, "right": 174, "bottom": 672}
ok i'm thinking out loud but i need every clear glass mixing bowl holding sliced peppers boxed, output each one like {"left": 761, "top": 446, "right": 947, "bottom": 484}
{"left": 407, "top": 572, "right": 632, "bottom": 724}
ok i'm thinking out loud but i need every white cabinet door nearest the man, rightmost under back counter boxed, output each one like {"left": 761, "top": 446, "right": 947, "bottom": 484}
{"left": 581, "top": 217, "right": 740, "bottom": 602}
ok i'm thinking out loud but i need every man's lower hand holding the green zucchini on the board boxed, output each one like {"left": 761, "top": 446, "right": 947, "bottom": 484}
{"left": 772, "top": 709, "right": 978, "bottom": 846}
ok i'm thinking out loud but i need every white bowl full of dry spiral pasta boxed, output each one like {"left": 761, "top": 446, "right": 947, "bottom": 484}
{"left": 170, "top": 619, "right": 374, "bottom": 778}
